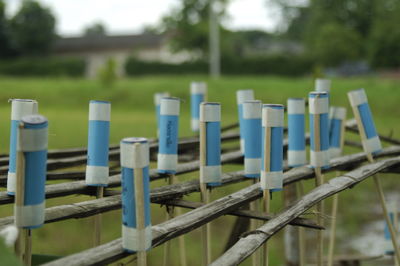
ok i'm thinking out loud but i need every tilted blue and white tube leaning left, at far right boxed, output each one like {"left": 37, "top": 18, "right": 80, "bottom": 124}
{"left": 347, "top": 89, "right": 382, "bottom": 154}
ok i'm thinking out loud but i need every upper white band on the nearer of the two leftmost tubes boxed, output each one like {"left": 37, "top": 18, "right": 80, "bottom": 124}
{"left": 17, "top": 127, "right": 48, "bottom": 152}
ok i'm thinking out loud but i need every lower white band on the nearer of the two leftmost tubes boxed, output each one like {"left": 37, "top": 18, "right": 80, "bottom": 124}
{"left": 14, "top": 201, "right": 45, "bottom": 227}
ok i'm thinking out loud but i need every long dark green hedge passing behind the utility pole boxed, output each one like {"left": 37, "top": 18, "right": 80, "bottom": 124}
{"left": 125, "top": 54, "right": 312, "bottom": 76}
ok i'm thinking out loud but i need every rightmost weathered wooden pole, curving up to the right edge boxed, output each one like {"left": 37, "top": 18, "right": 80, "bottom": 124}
{"left": 211, "top": 157, "right": 400, "bottom": 266}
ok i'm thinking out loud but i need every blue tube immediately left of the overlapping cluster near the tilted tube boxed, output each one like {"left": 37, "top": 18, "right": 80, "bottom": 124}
{"left": 287, "top": 98, "right": 307, "bottom": 167}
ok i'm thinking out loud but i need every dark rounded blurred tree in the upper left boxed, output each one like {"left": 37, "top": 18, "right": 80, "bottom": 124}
{"left": 11, "top": 0, "right": 55, "bottom": 55}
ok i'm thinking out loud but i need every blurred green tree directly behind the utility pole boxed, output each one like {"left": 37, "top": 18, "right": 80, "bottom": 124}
{"left": 162, "top": 0, "right": 230, "bottom": 58}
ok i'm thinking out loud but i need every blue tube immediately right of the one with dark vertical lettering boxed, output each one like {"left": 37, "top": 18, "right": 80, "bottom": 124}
{"left": 200, "top": 102, "right": 222, "bottom": 186}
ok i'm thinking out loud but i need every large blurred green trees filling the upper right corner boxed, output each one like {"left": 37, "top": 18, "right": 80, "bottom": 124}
{"left": 266, "top": 0, "right": 400, "bottom": 66}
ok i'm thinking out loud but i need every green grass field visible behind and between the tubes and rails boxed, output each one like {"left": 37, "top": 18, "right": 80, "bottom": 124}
{"left": 0, "top": 76, "right": 400, "bottom": 265}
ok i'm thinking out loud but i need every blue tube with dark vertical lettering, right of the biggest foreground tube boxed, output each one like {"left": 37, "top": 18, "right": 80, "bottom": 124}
{"left": 157, "top": 97, "right": 180, "bottom": 174}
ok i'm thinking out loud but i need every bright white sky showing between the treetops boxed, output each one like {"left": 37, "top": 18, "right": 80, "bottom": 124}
{"left": 5, "top": 0, "right": 277, "bottom": 36}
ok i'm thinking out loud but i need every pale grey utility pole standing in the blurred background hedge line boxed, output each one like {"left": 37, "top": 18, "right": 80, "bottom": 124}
{"left": 209, "top": 0, "right": 221, "bottom": 78}
